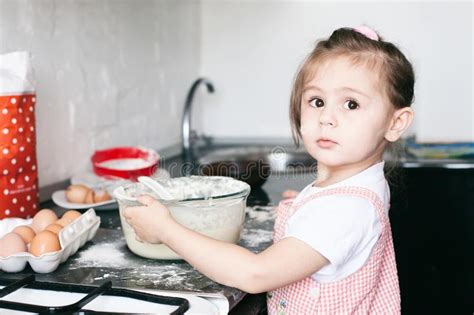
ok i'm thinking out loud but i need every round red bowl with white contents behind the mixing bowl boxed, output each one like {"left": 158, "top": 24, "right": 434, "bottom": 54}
{"left": 91, "top": 147, "right": 160, "bottom": 181}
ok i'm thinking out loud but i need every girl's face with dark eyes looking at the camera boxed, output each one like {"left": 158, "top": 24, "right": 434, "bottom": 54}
{"left": 301, "top": 56, "right": 395, "bottom": 172}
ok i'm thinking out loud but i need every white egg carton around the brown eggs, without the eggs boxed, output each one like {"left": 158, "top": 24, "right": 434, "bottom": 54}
{"left": 0, "top": 208, "right": 100, "bottom": 273}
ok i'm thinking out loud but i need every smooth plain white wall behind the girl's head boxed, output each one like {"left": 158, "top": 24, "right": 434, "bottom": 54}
{"left": 196, "top": 0, "right": 474, "bottom": 141}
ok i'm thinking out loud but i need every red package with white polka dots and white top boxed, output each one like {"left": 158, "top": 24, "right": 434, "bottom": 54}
{"left": 0, "top": 53, "right": 39, "bottom": 219}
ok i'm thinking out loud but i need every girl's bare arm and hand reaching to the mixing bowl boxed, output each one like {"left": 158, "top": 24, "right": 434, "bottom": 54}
{"left": 124, "top": 196, "right": 329, "bottom": 293}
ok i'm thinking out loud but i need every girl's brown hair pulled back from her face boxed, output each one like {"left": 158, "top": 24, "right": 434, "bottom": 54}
{"left": 290, "top": 28, "right": 415, "bottom": 145}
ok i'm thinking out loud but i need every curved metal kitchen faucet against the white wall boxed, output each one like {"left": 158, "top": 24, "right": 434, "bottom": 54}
{"left": 182, "top": 78, "right": 214, "bottom": 162}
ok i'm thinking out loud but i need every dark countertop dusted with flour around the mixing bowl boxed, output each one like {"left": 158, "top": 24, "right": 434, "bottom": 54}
{"left": 0, "top": 154, "right": 314, "bottom": 309}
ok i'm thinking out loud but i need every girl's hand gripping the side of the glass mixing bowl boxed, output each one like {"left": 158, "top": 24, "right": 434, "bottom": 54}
{"left": 123, "top": 195, "right": 174, "bottom": 244}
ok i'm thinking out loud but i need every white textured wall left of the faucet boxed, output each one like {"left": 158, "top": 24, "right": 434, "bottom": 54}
{"left": 0, "top": 0, "right": 200, "bottom": 186}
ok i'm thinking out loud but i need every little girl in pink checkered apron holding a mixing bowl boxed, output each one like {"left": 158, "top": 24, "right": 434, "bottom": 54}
{"left": 124, "top": 26, "right": 414, "bottom": 314}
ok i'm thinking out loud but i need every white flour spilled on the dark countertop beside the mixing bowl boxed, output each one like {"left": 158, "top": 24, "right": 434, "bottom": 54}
{"left": 65, "top": 206, "right": 275, "bottom": 292}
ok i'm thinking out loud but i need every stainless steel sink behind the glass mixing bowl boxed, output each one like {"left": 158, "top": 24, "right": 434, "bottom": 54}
{"left": 198, "top": 145, "right": 316, "bottom": 187}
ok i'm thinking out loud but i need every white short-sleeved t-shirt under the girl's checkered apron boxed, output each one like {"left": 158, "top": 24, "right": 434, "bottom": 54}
{"left": 285, "top": 162, "right": 390, "bottom": 283}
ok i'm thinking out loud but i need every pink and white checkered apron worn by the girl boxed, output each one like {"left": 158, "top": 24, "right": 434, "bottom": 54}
{"left": 267, "top": 187, "right": 400, "bottom": 315}
